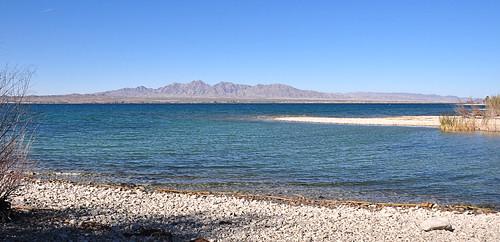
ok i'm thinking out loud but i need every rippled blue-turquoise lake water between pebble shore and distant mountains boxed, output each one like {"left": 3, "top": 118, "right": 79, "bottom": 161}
{"left": 31, "top": 104, "right": 500, "bottom": 207}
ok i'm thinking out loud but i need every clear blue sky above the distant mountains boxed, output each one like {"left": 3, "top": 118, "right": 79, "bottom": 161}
{"left": 0, "top": 0, "right": 500, "bottom": 97}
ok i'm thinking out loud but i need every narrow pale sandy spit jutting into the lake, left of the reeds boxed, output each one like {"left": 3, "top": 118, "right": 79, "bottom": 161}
{"left": 273, "top": 116, "right": 439, "bottom": 127}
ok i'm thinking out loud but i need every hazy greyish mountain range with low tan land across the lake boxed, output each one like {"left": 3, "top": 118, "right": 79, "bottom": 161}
{"left": 27, "top": 81, "right": 465, "bottom": 103}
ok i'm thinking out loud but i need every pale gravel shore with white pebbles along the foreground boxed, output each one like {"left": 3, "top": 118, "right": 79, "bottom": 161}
{"left": 0, "top": 180, "right": 500, "bottom": 241}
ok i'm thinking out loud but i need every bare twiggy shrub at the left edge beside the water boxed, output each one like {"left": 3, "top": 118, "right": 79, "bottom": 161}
{"left": 0, "top": 66, "right": 33, "bottom": 222}
